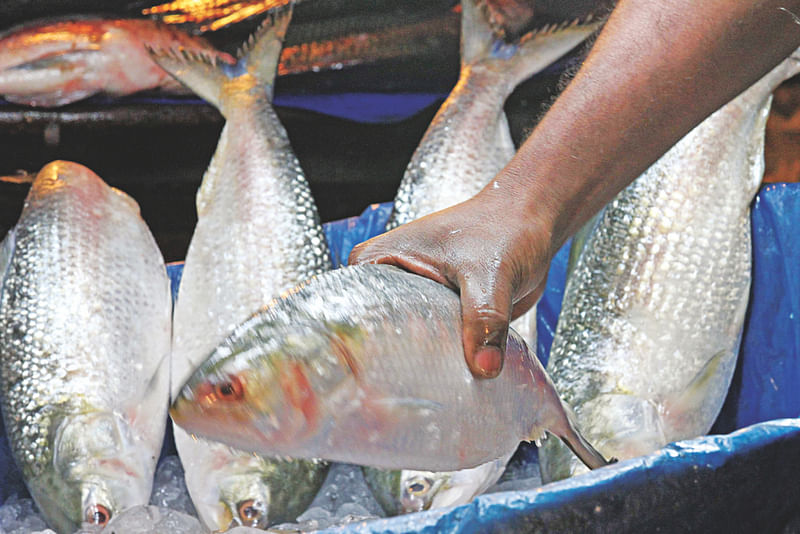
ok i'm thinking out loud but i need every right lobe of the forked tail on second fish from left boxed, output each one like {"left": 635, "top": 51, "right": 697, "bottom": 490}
{"left": 237, "top": 1, "right": 294, "bottom": 101}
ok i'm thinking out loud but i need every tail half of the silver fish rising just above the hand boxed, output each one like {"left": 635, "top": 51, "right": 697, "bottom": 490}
{"left": 386, "top": 0, "right": 599, "bottom": 230}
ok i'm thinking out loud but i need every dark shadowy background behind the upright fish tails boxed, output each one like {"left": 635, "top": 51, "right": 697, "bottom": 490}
{"left": 0, "top": 0, "right": 800, "bottom": 261}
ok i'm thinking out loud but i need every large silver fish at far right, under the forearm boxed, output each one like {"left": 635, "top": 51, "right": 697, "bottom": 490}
{"left": 539, "top": 52, "right": 800, "bottom": 481}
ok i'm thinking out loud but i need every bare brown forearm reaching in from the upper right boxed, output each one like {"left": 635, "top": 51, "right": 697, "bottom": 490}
{"left": 496, "top": 0, "right": 800, "bottom": 254}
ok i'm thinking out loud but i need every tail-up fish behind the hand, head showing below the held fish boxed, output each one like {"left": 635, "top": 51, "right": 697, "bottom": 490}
{"left": 364, "top": 0, "right": 599, "bottom": 512}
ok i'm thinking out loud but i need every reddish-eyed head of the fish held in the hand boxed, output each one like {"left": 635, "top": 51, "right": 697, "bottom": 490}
{"left": 170, "top": 323, "right": 344, "bottom": 456}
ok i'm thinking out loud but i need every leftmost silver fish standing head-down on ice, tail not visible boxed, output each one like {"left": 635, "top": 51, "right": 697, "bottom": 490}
{"left": 0, "top": 161, "right": 172, "bottom": 534}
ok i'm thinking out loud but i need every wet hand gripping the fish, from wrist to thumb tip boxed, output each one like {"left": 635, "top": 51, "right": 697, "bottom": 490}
{"left": 349, "top": 189, "right": 551, "bottom": 378}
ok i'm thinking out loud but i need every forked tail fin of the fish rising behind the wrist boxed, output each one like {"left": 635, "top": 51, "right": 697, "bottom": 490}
{"left": 461, "top": 0, "right": 602, "bottom": 90}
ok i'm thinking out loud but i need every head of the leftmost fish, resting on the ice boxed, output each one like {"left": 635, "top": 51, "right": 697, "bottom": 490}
{"left": 28, "top": 412, "right": 155, "bottom": 532}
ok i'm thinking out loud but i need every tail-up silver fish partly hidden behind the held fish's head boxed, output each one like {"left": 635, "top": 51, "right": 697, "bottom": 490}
{"left": 152, "top": 4, "right": 331, "bottom": 530}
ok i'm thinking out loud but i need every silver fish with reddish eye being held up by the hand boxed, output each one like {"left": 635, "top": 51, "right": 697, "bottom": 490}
{"left": 170, "top": 265, "right": 607, "bottom": 471}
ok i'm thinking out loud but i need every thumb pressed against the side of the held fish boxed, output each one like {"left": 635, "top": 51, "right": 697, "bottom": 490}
{"left": 459, "top": 272, "right": 511, "bottom": 378}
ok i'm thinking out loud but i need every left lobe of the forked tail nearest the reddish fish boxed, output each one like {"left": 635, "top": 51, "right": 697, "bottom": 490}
{"left": 145, "top": 45, "right": 230, "bottom": 111}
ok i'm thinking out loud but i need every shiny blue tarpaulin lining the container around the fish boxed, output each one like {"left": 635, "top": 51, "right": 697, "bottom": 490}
{"left": 0, "top": 184, "right": 800, "bottom": 534}
